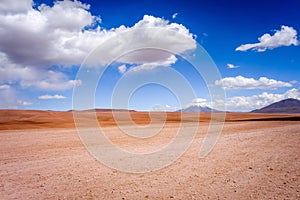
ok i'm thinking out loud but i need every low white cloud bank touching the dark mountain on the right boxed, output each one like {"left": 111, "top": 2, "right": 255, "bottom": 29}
{"left": 218, "top": 88, "right": 300, "bottom": 111}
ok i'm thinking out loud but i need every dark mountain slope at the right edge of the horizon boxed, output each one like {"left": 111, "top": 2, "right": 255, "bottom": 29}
{"left": 251, "top": 99, "right": 300, "bottom": 113}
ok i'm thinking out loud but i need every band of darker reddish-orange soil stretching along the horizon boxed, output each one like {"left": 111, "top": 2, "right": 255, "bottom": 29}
{"left": 0, "top": 109, "right": 300, "bottom": 130}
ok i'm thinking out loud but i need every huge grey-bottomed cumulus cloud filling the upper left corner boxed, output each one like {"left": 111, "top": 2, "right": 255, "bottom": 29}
{"left": 0, "top": 0, "right": 99, "bottom": 66}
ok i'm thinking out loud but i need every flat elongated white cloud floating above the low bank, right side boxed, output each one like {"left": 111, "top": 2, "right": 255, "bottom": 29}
{"left": 215, "top": 76, "right": 292, "bottom": 90}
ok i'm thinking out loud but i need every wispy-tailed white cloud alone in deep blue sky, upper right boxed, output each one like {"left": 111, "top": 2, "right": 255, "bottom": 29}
{"left": 235, "top": 26, "right": 299, "bottom": 52}
